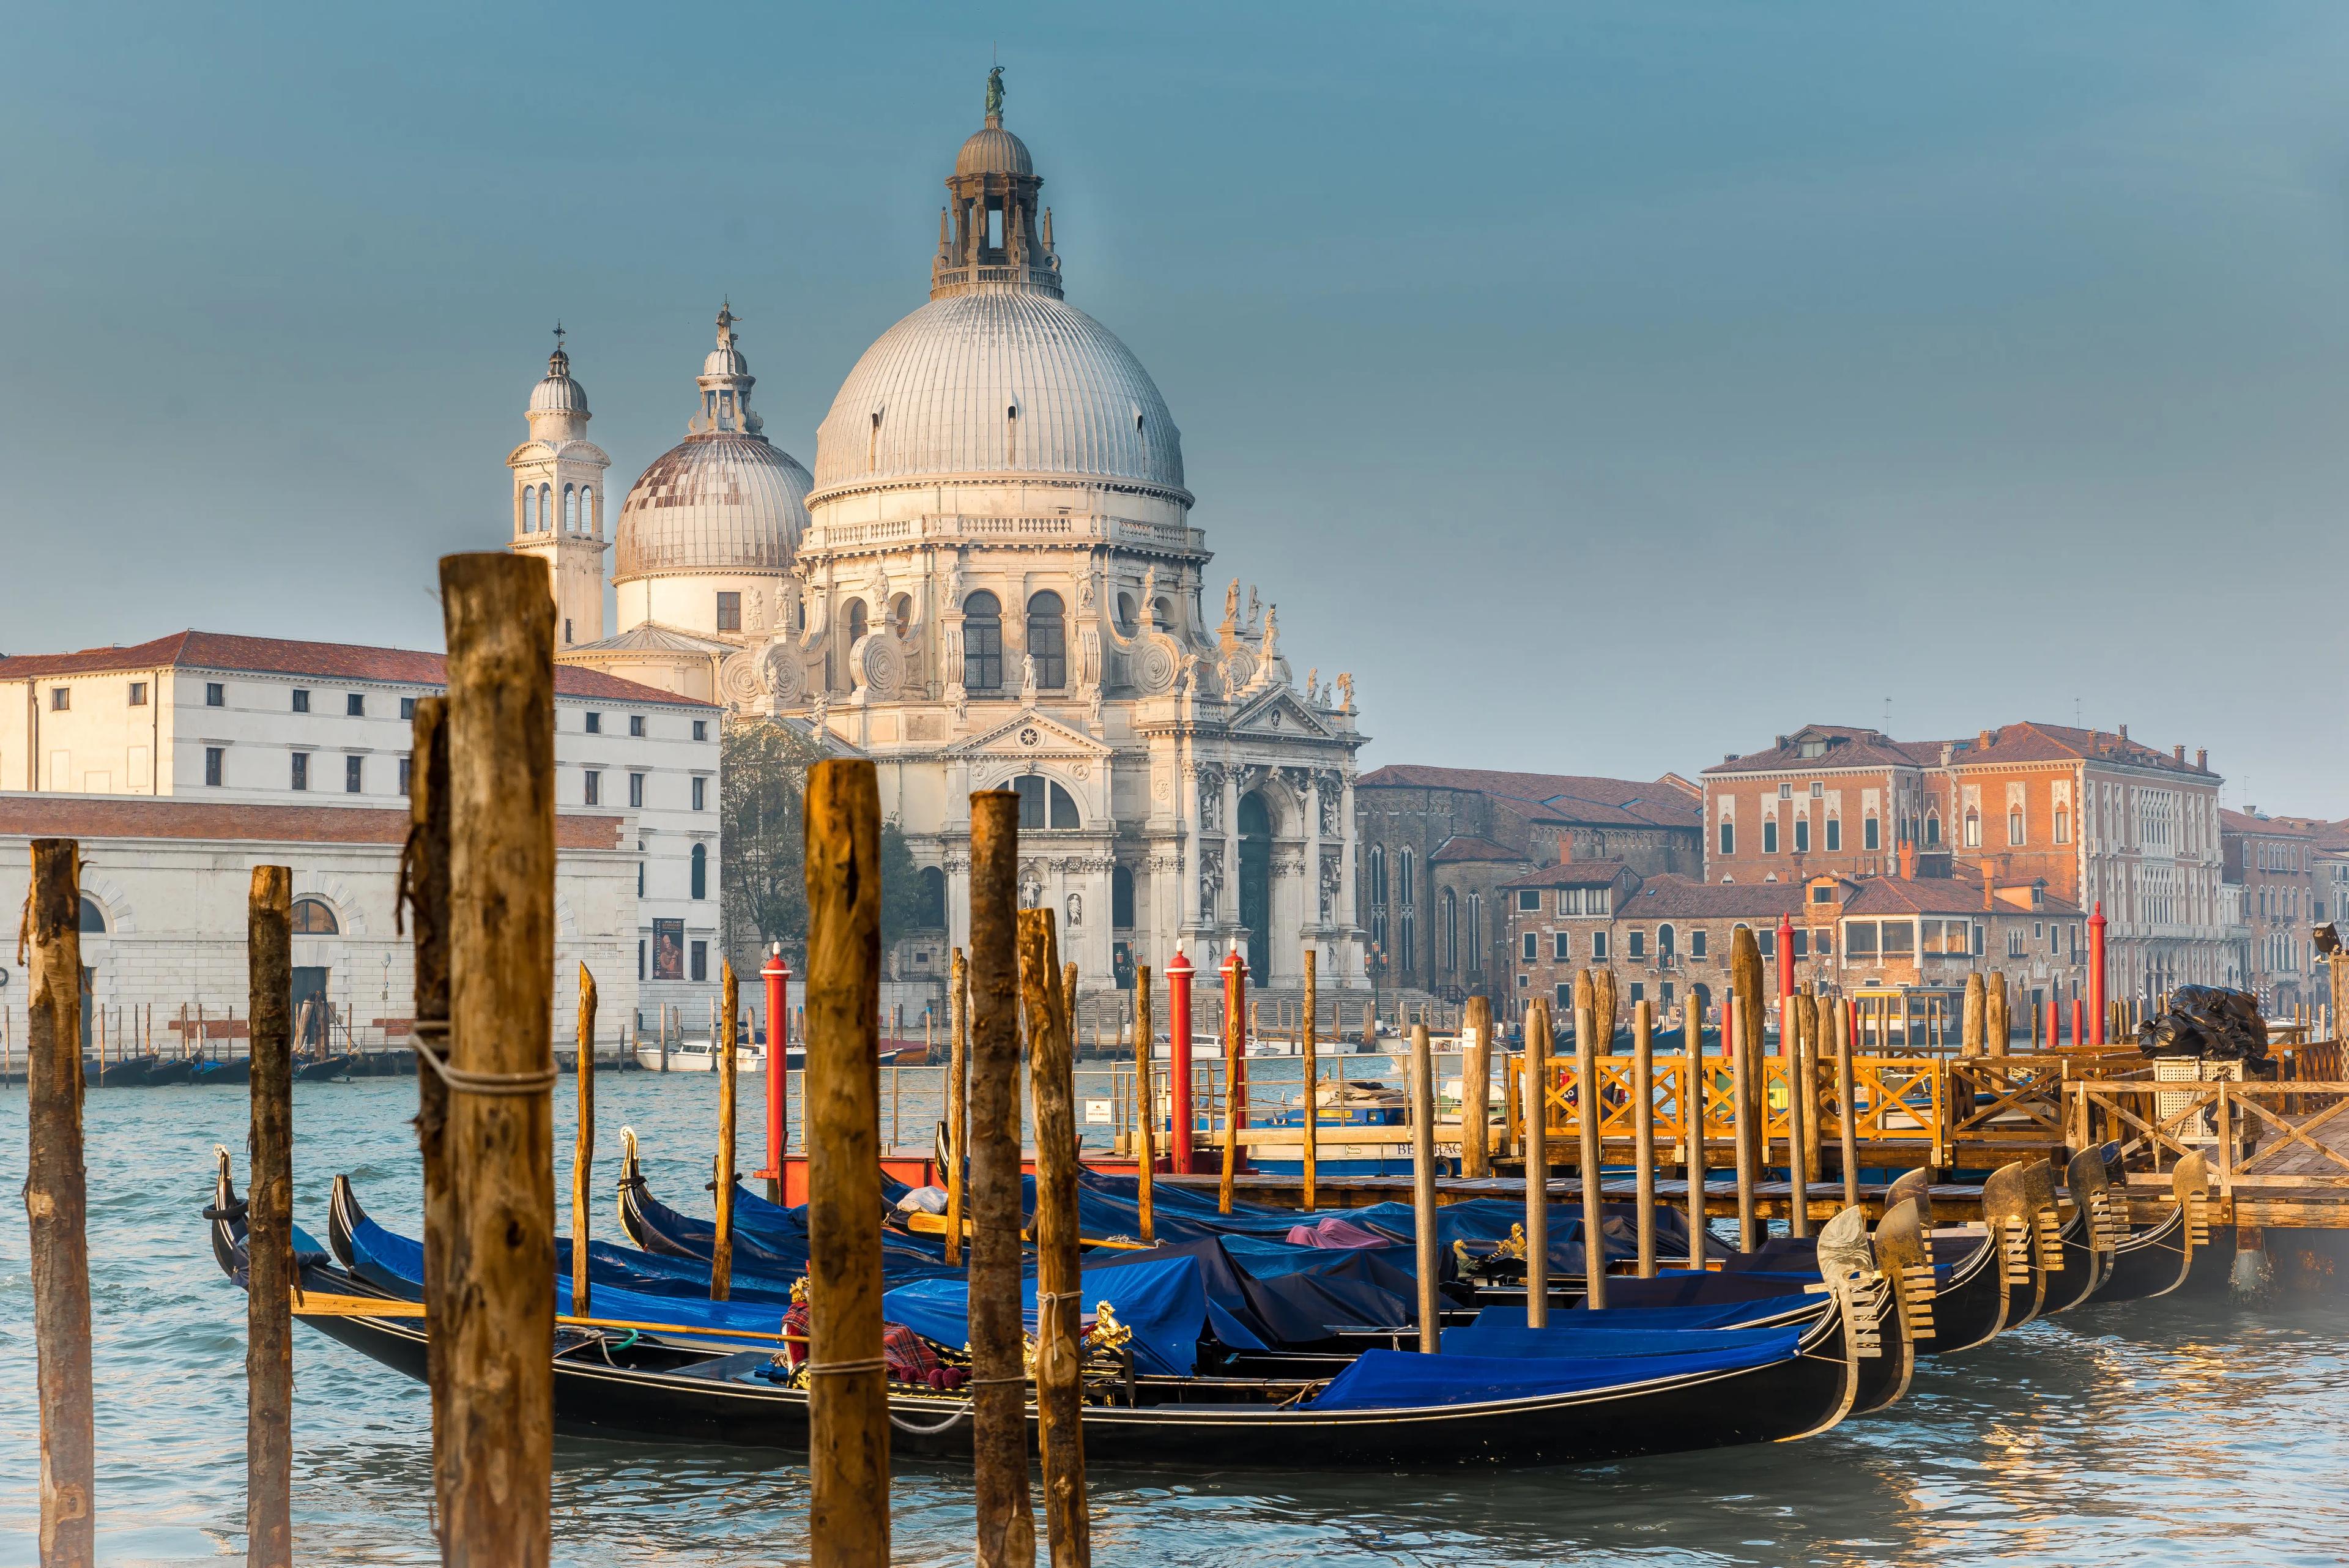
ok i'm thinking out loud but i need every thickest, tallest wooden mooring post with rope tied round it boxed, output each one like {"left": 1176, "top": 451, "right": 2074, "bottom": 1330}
{"left": 425, "top": 552, "right": 554, "bottom": 1568}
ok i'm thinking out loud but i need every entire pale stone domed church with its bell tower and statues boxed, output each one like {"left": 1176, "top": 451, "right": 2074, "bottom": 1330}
{"left": 510, "top": 78, "right": 1365, "bottom": 990}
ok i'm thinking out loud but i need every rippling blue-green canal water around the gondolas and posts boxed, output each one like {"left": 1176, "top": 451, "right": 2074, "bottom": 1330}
{"left": 0, "top": 1074, "right": 2349, "bottom": 1568}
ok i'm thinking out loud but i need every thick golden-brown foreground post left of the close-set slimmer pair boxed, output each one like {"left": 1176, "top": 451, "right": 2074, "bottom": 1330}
{"left": 803, "top": 757, "right": 883, "bottom": 1568}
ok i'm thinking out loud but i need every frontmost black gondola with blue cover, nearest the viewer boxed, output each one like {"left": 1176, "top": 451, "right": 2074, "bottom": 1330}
{"left": 207, "top": 1150, "right": 1856, "bottom": 1470}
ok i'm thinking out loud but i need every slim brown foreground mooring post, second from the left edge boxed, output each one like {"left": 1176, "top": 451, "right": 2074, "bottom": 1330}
{"left": 244, "top": 865, "right": 296, "bottom": 1568}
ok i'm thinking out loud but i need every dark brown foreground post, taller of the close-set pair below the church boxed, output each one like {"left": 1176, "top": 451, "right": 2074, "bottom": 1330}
{"left": 968, "top": 790, "right": 1036, "bottom": 1568}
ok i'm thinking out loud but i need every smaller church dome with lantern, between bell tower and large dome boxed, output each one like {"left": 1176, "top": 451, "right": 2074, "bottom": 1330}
{"left": 613, "top": 308, "right": 811, "bottom": 583}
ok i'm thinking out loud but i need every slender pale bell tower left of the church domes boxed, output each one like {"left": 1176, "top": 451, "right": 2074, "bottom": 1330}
{"left": 505, "top": 324, "right": 610, "bottom": 651}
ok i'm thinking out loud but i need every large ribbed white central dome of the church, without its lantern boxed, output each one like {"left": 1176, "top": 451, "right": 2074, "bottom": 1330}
{"left": 815, "top": 287, "right": 1189, "bottom": 503}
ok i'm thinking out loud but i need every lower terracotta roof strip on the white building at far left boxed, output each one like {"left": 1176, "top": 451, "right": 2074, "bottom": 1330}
{"left": 0, "top": 795, "right": 627, "bottom": 849}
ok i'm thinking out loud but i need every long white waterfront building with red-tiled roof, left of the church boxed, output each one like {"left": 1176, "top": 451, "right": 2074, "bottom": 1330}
{"left": 0, "top": 633, "right": 719, "bottom": 1048}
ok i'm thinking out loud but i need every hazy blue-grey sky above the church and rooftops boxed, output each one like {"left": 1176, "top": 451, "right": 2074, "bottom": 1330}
{"left": 0, "top": 12, "right": 2349, "bottom": 816}
